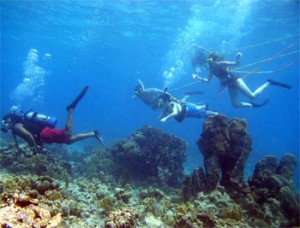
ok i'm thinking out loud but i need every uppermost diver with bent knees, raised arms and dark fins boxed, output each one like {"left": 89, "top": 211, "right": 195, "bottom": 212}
{"left": 192, "top": 52, "right": 291, "bottom": 108}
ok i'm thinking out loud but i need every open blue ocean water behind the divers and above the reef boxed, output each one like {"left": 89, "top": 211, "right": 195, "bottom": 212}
{"left": 1, "top": 0, "right": 300, "bottom": 188}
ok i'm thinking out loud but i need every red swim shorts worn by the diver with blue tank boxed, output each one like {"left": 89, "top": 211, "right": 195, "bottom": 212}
{"left": 41, "top": 127, "right": 71, "bottom": 144}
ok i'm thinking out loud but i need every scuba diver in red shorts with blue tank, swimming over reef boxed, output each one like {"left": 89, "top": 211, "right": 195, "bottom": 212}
{"left": 1, "top": 86, "right": 103, "bottom": 153}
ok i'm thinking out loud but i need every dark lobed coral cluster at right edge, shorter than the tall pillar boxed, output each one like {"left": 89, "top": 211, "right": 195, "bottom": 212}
{"left": 248, "top": 154, "right": 300, "bottom": 226}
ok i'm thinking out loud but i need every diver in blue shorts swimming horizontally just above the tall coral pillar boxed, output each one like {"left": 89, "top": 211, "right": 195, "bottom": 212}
{"left": 158, "top": 94, "right": 219, "bottom": 123}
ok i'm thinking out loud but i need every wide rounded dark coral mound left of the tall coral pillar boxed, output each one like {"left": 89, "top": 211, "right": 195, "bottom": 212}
{"left": 112, "top": 126, "right": 187, "bottom": 186}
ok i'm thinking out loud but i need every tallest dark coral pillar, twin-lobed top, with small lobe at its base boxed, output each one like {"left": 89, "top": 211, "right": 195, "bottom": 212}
{"left": 184, "top": 115, "right": 252, "bottom": 197}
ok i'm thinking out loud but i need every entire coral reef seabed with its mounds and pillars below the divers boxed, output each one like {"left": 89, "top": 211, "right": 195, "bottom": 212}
{"left": 0, "top": 121, "right": 300, "bottom": 228}
